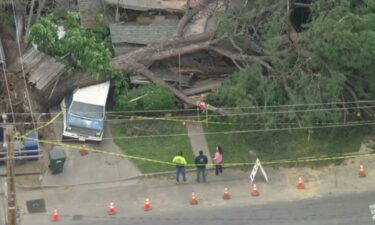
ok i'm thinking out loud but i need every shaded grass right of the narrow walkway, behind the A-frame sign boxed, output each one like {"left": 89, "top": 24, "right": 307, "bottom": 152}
{"left": 204, "top": 121, "right": 370, "bottom": 165}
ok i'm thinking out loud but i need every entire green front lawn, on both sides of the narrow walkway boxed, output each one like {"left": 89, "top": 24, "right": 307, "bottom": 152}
{"left": 111, "top": 115, "right": 371, "bottom": 173}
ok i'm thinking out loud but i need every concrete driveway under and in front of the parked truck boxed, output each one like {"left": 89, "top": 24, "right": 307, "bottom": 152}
{"left": 42, "top": 108, "right": 141, "bottom": 186}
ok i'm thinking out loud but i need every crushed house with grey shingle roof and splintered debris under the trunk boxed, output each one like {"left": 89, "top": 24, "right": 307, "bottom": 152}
{"left": 78, "top": 0, "right": 225, "bottom": 96}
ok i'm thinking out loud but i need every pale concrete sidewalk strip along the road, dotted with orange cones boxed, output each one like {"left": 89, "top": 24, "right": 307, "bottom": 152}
{"left": 18, "top": 154, "right": 375, "bottom": 221}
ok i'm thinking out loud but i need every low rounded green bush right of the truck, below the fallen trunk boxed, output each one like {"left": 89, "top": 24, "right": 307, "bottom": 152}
{"left": 115, "top": 85, "right": 177, "bottom": 111}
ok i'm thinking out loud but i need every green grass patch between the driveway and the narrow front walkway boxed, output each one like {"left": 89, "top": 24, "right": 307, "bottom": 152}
{"left": 111, "top": 120, "right": 194, "bottom": 173}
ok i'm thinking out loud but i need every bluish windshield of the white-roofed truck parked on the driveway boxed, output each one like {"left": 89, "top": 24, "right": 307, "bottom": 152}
{"left": 70, "top": 101, "right": 104, "bottom": 119}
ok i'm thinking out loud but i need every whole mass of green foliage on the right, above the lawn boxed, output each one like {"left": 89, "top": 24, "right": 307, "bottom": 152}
{"left": 206, "top": 0, "right": 375, "bottom": 127}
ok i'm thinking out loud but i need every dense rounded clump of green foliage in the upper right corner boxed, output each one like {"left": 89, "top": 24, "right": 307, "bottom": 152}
{"left": 302, "top": 0, "right": 375, "bottom": 99}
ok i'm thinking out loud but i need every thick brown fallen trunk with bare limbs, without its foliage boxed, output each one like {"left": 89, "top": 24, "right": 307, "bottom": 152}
{"left": 0, "top": 0, "right": 271, "bottom": 116}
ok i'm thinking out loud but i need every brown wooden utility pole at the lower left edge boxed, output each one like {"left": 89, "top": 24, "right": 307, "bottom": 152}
{"left": 6, "top": 125, "right": 17, "bottom": 225}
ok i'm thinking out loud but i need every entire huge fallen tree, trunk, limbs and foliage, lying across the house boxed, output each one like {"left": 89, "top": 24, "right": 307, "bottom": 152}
{"left": 1, "top": 0, "right": 373, "bottom": 124}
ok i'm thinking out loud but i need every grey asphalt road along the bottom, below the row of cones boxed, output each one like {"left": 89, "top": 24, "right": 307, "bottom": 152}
{"left": 22, "top": 192, "right": 375, "bottom": 225}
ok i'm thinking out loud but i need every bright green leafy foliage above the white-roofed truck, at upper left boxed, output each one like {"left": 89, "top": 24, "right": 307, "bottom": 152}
{"left": 28, "top": 12, "right": 119, "bottom": 78}
